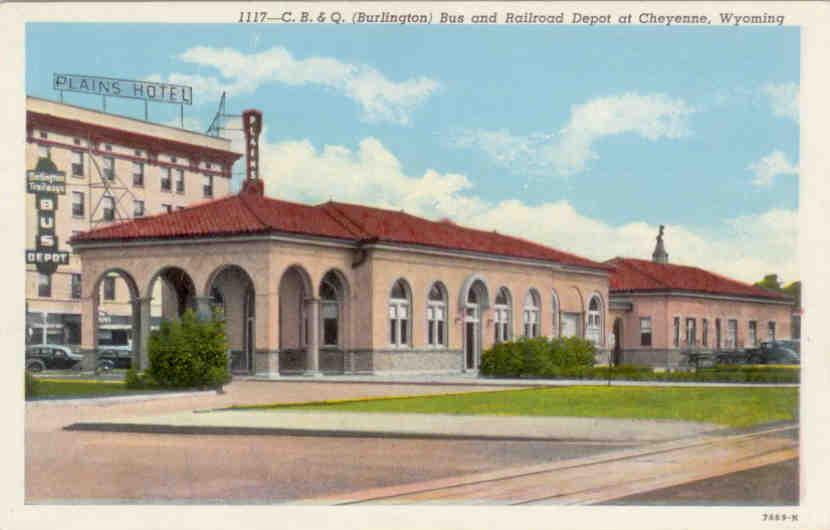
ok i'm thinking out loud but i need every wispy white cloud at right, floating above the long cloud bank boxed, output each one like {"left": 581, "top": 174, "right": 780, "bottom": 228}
{"left": 452, "top": 93, "right": 694, "bottom": 176}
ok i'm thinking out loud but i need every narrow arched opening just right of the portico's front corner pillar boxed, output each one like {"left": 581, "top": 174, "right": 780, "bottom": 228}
{"left": 279, "top": 265, "right": 312, "bottom": 373}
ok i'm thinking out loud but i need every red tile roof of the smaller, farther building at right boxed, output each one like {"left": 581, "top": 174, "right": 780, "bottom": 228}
{"left": 606, "top": 258, "right": 790, "bottom": 300}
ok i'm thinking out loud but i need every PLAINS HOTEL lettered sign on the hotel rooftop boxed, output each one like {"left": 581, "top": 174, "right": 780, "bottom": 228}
{"left": 52, "top": 74, "right": 193, "bottom": 105}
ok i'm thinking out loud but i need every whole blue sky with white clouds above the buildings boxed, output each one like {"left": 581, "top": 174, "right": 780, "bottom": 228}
{"left": 26, "top": 23, "right": 800, "bottom": 282}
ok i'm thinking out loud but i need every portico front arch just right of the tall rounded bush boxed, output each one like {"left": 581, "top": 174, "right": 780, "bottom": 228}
{"left": 206, "top": 265, "right": 256, "bottom": 374}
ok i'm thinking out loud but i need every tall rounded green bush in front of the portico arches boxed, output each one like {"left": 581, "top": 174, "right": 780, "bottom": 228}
{"left": 146, "top": 310, "right": 230, "bottom": 388}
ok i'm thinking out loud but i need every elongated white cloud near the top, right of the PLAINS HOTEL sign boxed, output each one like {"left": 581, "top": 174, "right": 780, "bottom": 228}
{"left": 150, "top": 46, "right": 439, "bottom": 125}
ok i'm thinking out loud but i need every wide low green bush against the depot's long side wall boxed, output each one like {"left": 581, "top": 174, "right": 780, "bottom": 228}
{"left": 481, "top": 337, "right": 596, "bottom": 377}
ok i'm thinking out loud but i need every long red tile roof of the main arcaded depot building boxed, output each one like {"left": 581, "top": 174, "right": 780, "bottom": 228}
{"left": 71, "top": 188, "right": 608, "bottom": 270}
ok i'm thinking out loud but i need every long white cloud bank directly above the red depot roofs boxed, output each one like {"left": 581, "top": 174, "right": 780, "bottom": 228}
{"left": 260, "top": 134, "right": 798, "bottom": 281}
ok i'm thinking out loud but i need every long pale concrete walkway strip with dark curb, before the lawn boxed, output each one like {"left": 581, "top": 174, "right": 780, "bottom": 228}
{"left": 66, "top": 410, "right": 720, "bottom": 443}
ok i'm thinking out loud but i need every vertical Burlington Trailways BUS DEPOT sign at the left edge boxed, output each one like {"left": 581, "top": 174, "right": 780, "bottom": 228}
{"left": 26, "top": 163, "right": 69, "bottom": 274}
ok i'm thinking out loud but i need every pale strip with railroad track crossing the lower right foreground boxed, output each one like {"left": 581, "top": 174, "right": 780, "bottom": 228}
{"left": 304, "top": 425, "right": 798, "bottom": 505}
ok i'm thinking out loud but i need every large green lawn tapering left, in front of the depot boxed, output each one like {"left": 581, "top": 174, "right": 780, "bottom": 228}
{"left": 245, "top": 386, "right": 798, "bottom": 427}
